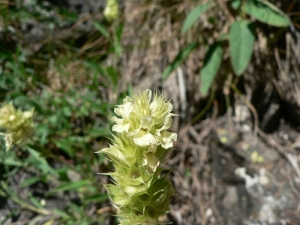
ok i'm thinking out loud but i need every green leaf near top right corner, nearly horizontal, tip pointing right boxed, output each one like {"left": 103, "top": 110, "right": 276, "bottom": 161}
{"left": 242, "top": 0, "right": 291, "bottom": 27}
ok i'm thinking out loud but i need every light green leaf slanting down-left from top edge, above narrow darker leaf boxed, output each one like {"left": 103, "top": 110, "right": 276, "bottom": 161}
{"left": 181, "top": 3, "right": 213, "bottom": 34}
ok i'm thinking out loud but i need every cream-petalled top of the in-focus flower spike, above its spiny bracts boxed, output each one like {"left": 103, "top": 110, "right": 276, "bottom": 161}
{"left": 112, "top": 89, "right": 177, "bottom": 149}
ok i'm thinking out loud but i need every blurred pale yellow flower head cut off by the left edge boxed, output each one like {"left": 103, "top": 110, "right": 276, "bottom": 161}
{"left": 0, "top": 102, "right": 33, "bottom": 150}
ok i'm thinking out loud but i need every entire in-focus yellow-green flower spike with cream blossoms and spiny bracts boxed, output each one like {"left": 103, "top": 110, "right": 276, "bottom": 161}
{"left": 99, "top": 90, "right": 177, "bottom": 225}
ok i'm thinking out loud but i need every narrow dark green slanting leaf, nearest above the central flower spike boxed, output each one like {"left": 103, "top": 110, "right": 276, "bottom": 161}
{"left": 162, "top": 43, "right": 198, "bottom": 79}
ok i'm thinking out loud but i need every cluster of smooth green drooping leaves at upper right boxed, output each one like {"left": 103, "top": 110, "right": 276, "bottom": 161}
{"left": 163, "top": 0, "right": 291, "bottom": 95}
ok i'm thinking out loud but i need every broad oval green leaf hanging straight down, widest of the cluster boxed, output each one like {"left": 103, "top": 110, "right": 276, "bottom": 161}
{"left": 229, "top": 20, "right": 255, "bottom": 76}
